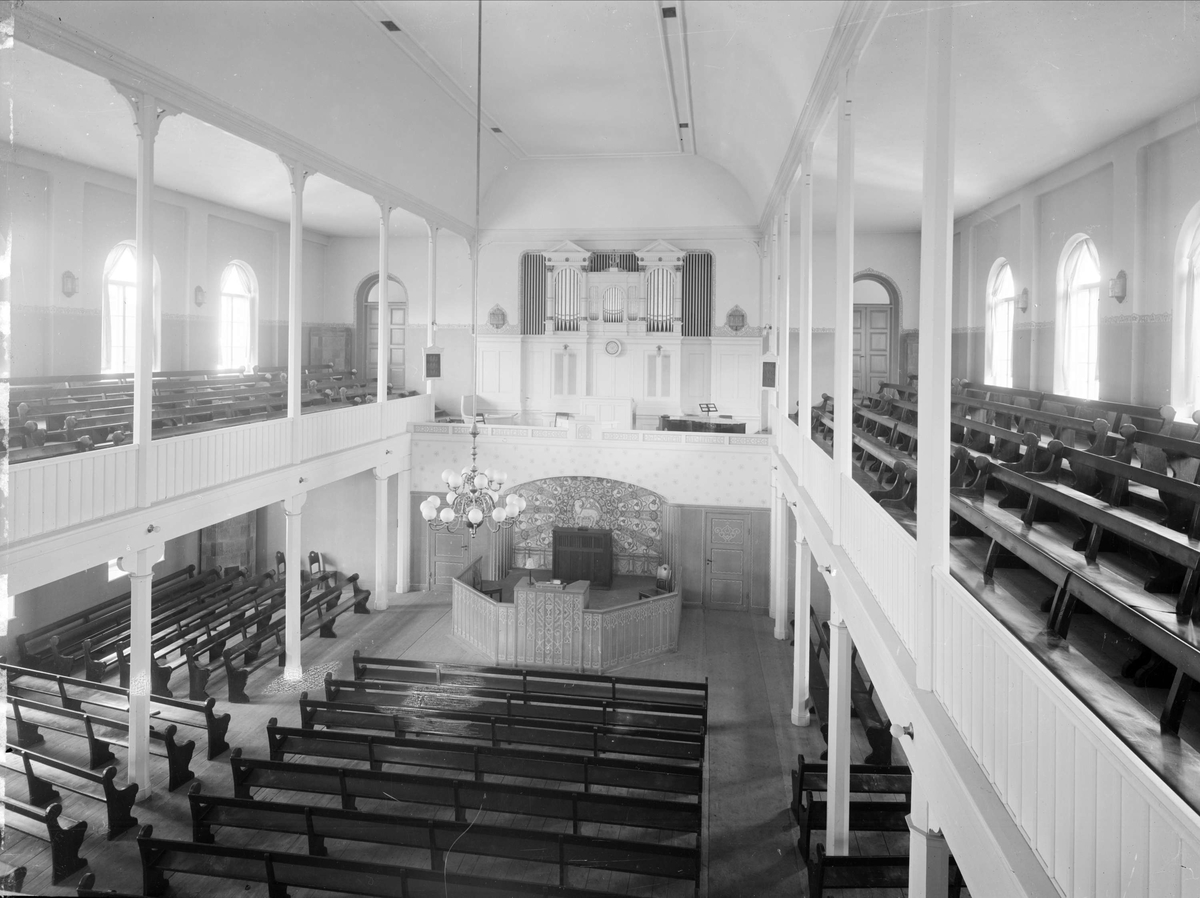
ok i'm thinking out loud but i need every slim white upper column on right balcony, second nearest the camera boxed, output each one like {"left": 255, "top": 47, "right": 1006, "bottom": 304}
{"left": 830, "top": 68, "right": 854, "bottom": 545}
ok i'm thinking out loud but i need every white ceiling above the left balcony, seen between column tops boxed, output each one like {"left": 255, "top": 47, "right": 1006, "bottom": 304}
{"left": 5, "top": 43, "right": 426, "bottom": 237}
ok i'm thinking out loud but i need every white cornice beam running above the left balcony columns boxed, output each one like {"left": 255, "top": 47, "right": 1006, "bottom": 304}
{"left": 13, "top": 6, "right": 474, "bottom": 239}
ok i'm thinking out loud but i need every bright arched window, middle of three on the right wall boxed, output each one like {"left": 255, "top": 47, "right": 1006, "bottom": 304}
{"left": 1056, "top": 234, "right": 1100, "bottom": 399}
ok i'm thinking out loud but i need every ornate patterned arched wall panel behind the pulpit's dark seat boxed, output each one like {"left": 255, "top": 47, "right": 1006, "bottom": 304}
{"left": 512, "top": 477, "right": 666, "bottom": 576}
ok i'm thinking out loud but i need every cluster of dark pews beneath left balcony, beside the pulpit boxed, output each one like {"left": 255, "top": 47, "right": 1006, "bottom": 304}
{"left": 16, "top": 552, "right": 371, "bottom": 704}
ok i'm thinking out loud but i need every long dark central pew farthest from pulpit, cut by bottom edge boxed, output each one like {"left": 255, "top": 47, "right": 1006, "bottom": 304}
{"left": 138, "top": 826, "right": 638, "bottom": 898}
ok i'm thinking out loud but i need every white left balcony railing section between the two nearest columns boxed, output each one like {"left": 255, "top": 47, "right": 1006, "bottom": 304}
{"left": 150, "top": 418, "right": 292, "bottom": 502}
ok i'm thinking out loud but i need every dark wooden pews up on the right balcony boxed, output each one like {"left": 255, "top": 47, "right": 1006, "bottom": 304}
{"left": 812, "top": 382, "right": 1200, "bottom": 787}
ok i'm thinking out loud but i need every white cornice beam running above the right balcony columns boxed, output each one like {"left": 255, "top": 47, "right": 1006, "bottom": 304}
{"left": 758, "top": 0, "right": 888, "bottom": 234}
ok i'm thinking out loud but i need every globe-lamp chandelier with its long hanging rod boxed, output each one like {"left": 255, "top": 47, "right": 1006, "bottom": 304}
{"left": 421, "top": 0, "right": 526, "bottom": 538}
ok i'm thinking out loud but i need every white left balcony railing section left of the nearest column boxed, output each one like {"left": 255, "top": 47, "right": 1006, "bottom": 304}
{"left": 6, "top": 445, "right": 138, "bottom": 541}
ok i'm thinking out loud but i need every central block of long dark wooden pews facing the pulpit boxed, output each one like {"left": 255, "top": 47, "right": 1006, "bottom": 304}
{"left": 93, "top": 653, "right": 708, "bottom": 898}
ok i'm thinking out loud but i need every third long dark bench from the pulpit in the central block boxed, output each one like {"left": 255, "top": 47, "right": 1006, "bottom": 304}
{"left": 300, "top": 693, "right": 704, "bottom": 761}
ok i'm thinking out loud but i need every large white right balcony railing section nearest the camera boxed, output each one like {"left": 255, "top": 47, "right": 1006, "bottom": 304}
{"left": 932, "top": 573, "right": 1200, "bottom": 898}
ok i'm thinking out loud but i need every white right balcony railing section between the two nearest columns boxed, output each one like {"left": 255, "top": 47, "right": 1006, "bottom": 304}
{"left": 844, "top": 477, "right": 917, "bottom": 655}
